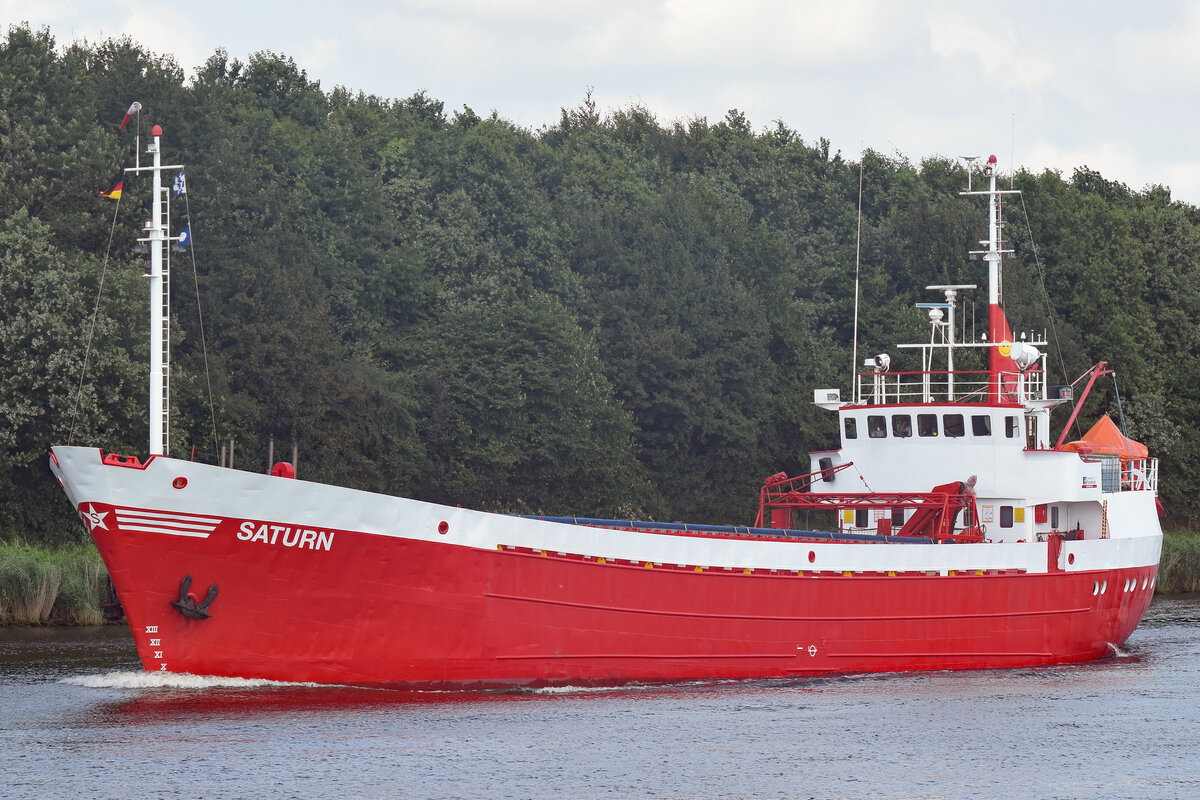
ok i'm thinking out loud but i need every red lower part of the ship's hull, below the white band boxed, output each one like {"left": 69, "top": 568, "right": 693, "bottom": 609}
{"left": 94, "top": 505, "right": 1157, "bottom": 687}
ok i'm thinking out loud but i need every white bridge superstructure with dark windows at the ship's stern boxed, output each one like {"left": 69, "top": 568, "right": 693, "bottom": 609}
{"left": 809, "top": 285, "right": 1158, "bottom": 541}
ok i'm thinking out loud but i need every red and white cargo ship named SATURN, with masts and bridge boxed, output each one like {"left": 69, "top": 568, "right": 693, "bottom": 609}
{"left": 50, "top": 126, "right": 1162, "bottom": 688}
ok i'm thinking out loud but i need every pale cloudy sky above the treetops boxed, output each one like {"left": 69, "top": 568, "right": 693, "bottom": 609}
{"left": 9, "top": 0, "right": 1200, "bottom": 205}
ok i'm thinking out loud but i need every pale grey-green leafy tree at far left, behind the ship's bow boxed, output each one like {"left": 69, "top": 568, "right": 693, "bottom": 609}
{"left": 0, "top": 211, "right": 146, "bottom": 541}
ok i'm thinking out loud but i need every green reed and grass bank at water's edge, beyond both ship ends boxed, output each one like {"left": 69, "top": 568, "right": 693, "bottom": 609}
{"left": 0, "top": 530, "right": 1200, "bottom": 625}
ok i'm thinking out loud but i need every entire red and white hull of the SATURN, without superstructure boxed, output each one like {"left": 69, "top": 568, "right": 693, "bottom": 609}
{"left": 55, "top": 449, "right": 1157, "bottom": 687}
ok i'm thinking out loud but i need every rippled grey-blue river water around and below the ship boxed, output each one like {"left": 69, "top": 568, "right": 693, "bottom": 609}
{"left": 0, "top": 596, "right": 1200, "bottom": 800}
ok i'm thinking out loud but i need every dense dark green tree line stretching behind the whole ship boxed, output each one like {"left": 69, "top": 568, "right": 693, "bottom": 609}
{"left": 0, "top": 26, "right": 1200, "bottom": 541}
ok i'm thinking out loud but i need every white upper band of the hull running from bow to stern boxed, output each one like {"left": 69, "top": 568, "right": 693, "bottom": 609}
{"left": 54, "top": 447, "right": 1162, "bottom": 575}
